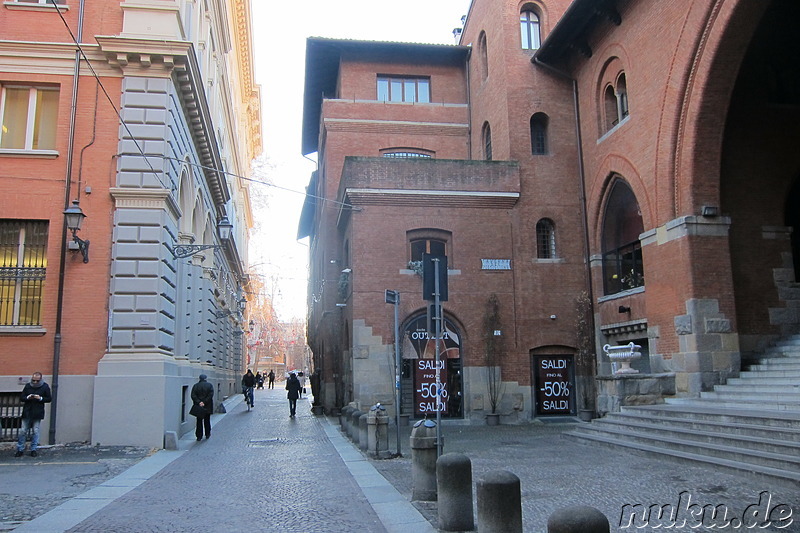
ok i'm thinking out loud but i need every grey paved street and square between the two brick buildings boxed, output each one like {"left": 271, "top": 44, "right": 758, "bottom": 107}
{"left": 0, "top": 389, "right": 800, "bottom": 533}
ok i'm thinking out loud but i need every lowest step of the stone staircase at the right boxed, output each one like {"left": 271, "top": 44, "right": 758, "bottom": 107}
{"left": 567, "top": 431, "right": 800, "bottom": 488}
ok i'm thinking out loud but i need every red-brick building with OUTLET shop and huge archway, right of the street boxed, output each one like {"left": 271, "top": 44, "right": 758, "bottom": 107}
{"left": 299, "top": 0, "right": 800, "bottom": 422}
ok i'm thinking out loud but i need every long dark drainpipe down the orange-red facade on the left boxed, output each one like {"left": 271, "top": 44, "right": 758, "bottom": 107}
{"left": 49, "top": 0, "right": 85, "bottom": 444}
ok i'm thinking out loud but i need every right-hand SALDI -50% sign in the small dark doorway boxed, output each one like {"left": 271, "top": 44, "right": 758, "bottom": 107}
{"left": 533, "top": 355, "right": 575, "bottom": 416}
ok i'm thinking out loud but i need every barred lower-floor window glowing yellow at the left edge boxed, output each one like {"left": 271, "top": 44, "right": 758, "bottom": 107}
{"left": 0, "top": 220, "right": 47, "bottom": 326}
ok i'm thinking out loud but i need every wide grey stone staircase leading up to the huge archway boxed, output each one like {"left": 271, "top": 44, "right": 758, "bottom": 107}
{"left": 567, "top": 335, "right": 800, "bottom": 486}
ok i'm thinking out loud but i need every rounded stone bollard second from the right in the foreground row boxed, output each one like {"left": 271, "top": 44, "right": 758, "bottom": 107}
{"left": 476, "top": 470, "right": 522, "bottom": 533}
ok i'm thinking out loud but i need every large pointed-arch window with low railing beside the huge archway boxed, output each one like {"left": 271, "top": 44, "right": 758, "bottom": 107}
{"left": 603, "top": 178, "right": 644, "bottom": 294}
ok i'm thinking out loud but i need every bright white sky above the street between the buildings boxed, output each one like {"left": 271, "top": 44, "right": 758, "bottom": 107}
{"left": 250, "top": 0, "right": 470, "bottom": 320}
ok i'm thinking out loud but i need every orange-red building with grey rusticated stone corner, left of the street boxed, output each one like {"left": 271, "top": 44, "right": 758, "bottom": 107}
{"left": 0, "top": 0, "right": 260, "bottom": 447}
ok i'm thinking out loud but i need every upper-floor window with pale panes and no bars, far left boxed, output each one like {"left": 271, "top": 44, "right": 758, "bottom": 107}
{"left": 0, "top": 85, "right": 58, "bottom": 150}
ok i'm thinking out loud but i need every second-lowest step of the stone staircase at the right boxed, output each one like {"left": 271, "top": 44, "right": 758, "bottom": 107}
{"left": 571, "top": 421, "right": 800, "bottom": 474}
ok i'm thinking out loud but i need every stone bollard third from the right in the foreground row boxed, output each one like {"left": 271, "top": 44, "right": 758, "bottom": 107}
{"left": 436, "top": 453, "right": 475, "bottom": 531}
